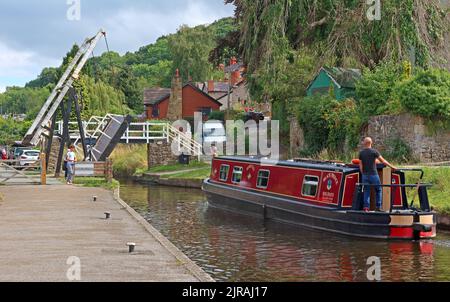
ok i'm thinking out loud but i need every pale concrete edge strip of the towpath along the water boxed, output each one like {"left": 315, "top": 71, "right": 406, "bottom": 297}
{"left": 114, "top": 188, "right": 216, "bottom": 282}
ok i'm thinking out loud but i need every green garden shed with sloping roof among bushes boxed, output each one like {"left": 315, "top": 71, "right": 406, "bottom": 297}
{"left": 306, "top": 66, "right": 361, "bottom": 101}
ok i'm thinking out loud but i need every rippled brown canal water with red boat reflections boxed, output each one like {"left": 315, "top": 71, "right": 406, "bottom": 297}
{"left": 121, "top": 183, "right": 450, "bottom": 281}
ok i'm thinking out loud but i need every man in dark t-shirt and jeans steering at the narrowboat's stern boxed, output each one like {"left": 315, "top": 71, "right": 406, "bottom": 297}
{"left": 359, "top": 137, "right": 397, "bottom": 213}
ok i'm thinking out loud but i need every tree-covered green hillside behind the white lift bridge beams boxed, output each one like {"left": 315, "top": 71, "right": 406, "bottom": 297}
{"left": 0, "top": 18, "right": 236, "bottom": 119}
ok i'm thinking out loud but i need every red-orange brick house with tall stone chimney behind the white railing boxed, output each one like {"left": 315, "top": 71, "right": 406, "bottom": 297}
{"left": 144, "top": 70, "right": 222, "bottom": 121}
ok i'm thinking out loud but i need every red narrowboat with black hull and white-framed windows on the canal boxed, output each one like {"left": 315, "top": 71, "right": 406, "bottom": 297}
{"left": 203, "top": 157, "right": 436, "bottom": 240}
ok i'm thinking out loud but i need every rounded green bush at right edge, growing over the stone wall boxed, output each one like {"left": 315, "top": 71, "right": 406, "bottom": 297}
{"left": 398, "top": 69, "right": 450, "bottom": 120}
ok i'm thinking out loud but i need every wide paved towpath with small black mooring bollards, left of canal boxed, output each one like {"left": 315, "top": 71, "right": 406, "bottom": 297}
{"left": 0, "top": 185, "right": 212, "bottom": 282}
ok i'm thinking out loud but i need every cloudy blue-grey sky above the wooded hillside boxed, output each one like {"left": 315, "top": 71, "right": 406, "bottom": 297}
{"left": 0, "top": 0, "right": 234, "bottom": 92}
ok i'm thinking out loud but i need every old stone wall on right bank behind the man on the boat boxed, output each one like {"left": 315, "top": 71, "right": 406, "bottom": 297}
{"left": 367, "top": 114, "right": 450, "bottom": 163}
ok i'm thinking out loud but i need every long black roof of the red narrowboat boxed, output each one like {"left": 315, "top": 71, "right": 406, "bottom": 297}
{"left": 217, "top": 156, "right": 370, "bottom": 173}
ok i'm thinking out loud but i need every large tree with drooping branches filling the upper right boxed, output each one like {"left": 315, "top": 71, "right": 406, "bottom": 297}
{"left": 226, "top": 0, "right": 450, "bottom": 99}
